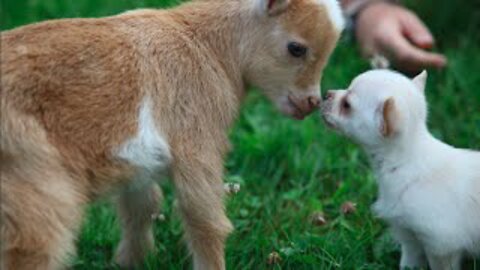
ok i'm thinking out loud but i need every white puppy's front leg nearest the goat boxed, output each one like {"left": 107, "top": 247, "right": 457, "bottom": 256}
{"left": 392, "top": 227, "right": 427, "bottom": 269}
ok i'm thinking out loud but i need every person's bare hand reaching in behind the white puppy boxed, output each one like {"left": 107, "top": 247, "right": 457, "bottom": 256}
{"left": 355, "top": 2, "right": 447, "bottom": 72}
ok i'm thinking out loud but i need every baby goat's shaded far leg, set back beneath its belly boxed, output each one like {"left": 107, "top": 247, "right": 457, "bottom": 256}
{"left": 115, "top": 181, "right": 162, "bottom": 268}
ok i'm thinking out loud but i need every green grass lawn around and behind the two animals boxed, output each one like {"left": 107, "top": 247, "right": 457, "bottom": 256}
{"left": 1, "top": 0, "right": 480, "bottom": 269}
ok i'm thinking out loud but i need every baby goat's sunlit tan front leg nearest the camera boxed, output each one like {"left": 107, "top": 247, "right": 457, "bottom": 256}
{"left": 173, "top": 155, "right": 232, "bottom": 270}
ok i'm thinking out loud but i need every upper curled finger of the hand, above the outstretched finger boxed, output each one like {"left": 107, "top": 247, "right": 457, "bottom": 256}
{"left": 401, "top": 13, "right": 435, "bottom": 49}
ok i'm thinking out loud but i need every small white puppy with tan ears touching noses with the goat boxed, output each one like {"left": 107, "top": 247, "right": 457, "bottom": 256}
{"left": 322, "top": 70, "right": 480, "bottom": 270}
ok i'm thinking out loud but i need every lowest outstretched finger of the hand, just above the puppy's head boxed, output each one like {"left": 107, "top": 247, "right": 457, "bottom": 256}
{"left": 385, "top": 35, "right": 447, "bottom": 70}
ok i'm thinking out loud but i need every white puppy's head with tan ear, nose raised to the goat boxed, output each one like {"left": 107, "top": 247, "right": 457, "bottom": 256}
{"left": 322, "top": 70, "right": 427, "bottom": 146}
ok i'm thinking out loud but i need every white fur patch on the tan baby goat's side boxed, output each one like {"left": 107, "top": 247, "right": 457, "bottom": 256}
{"left": 117, "top": 98, "right": 171, "bottom": 172}
